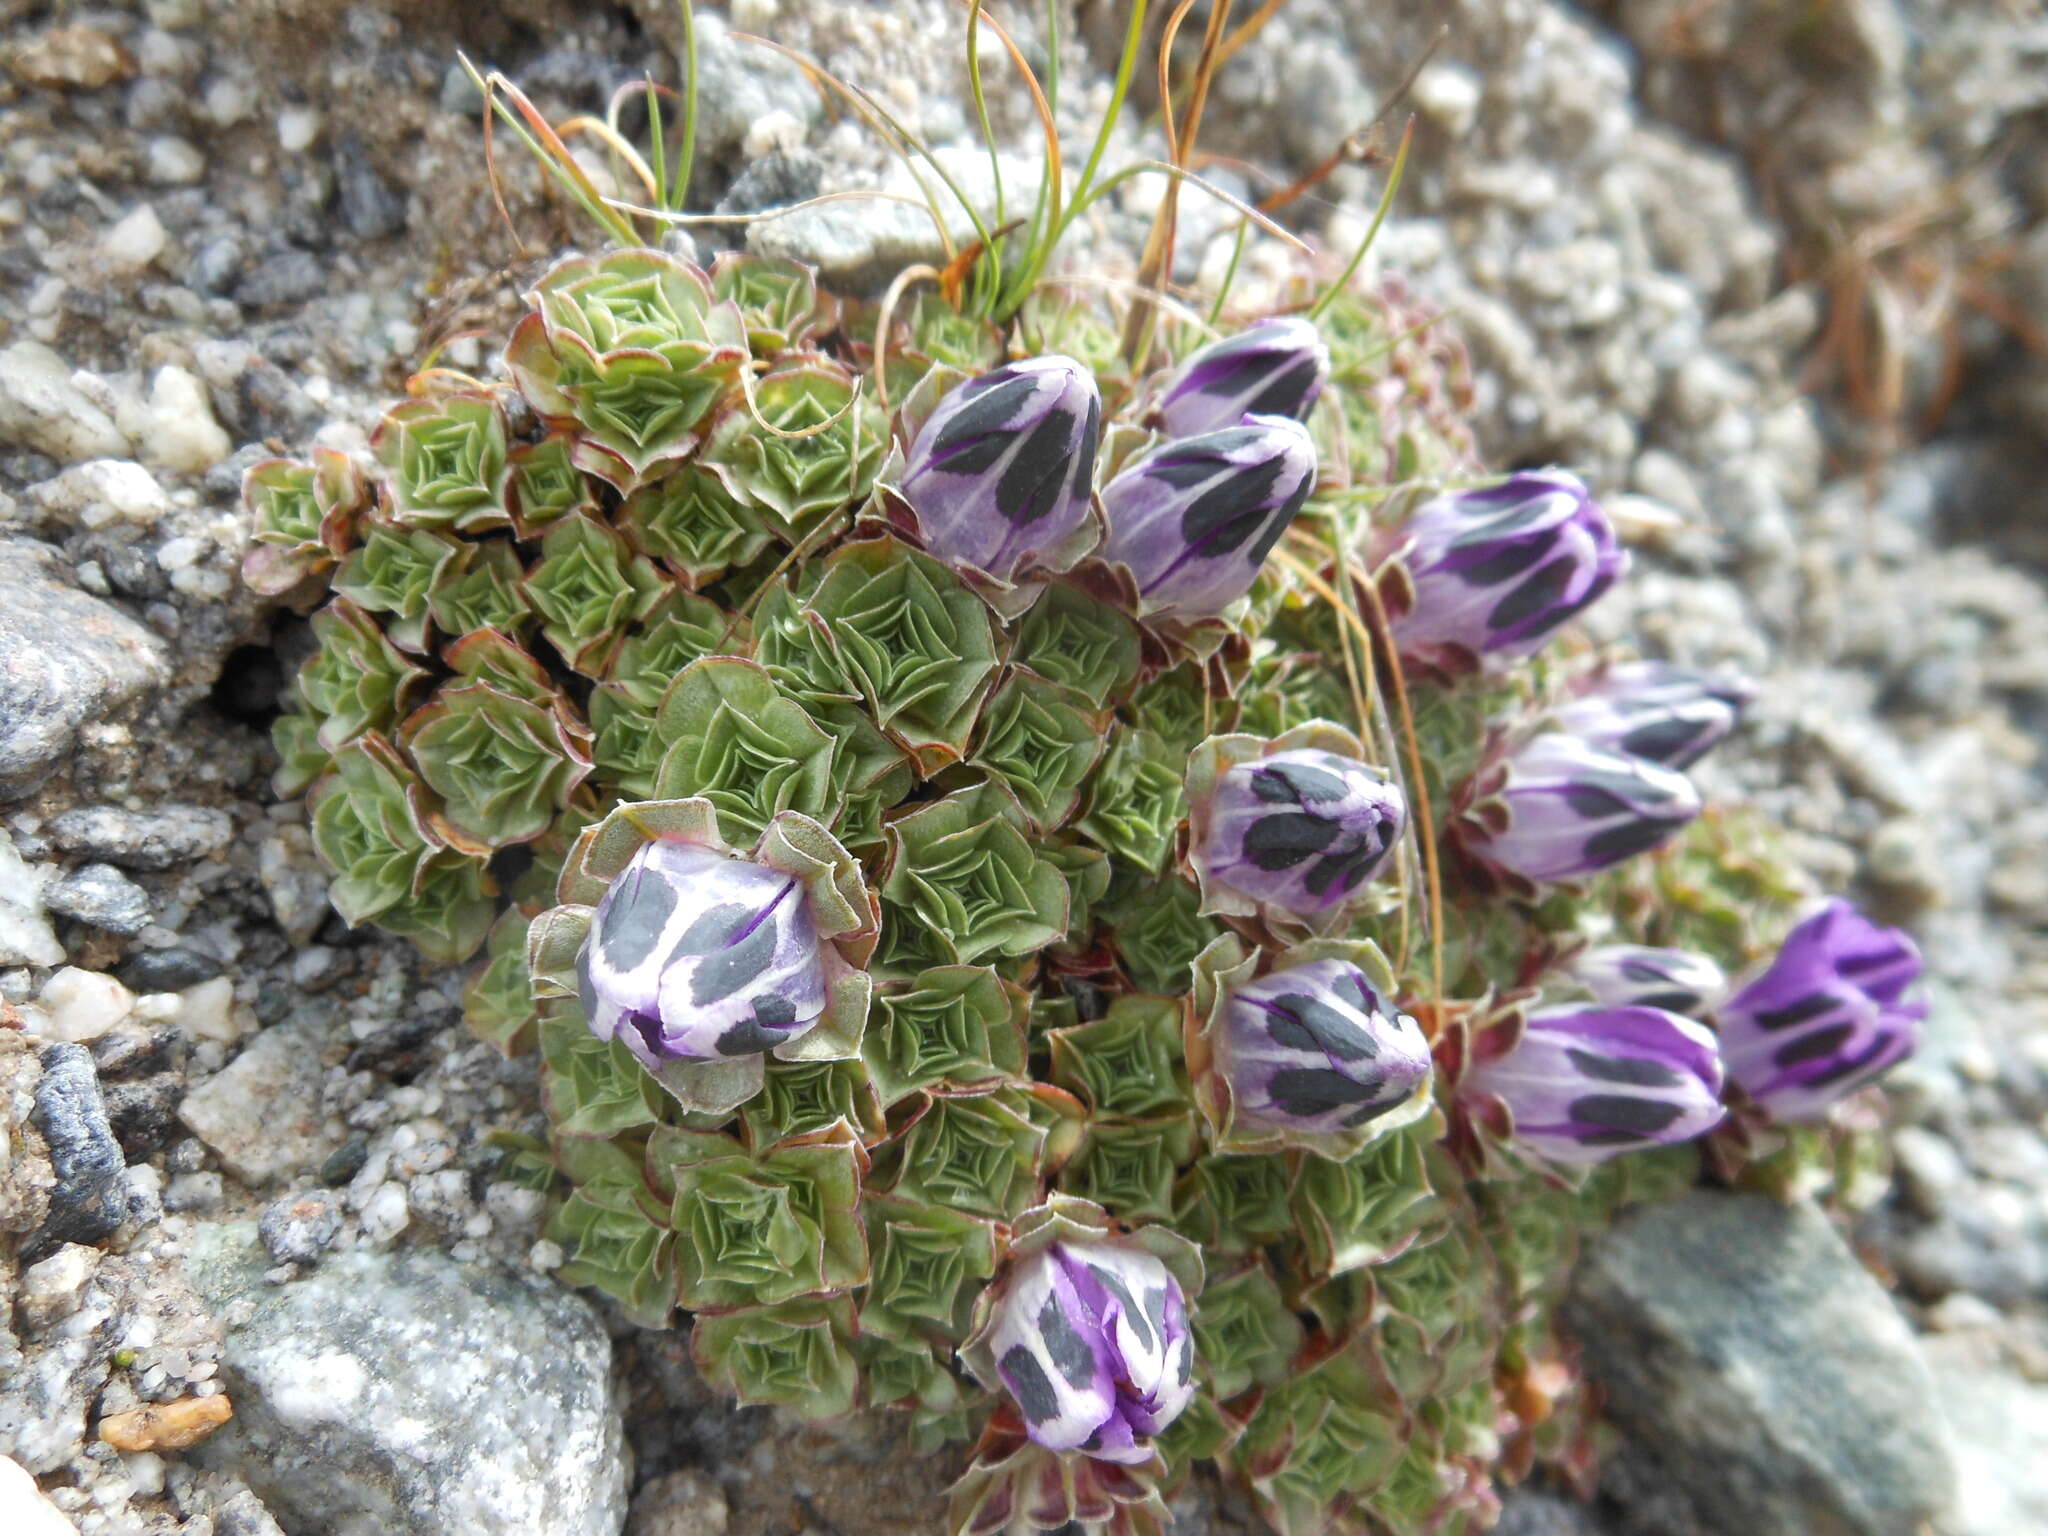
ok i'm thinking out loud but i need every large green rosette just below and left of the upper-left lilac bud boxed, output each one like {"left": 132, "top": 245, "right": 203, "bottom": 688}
{"left": 778, "top": 539, "right": 997, "bottom": 776}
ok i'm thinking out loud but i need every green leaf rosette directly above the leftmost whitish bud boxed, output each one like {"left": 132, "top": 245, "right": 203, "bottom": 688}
{"left": 655, "top": 655, "right": 844, "bottom": 842}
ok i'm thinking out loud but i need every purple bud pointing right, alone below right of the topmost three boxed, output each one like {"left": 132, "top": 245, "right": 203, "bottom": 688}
{"left": 1393, "top": 469, "right": 1628, "bottom": 666}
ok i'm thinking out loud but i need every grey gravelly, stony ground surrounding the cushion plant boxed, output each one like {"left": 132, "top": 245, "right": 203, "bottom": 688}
{"left": 0, "top": 0, "right": 2048, "bottom": 1536}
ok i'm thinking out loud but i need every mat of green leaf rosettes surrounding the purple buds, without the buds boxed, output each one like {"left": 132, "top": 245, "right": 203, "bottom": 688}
{"left": 248, "top": 250, "right": 1843, "bottom": 1536}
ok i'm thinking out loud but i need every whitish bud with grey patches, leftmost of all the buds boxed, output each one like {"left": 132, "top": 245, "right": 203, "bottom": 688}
{"left": 578, "top": 840, "right": 825, "bottom": 1069}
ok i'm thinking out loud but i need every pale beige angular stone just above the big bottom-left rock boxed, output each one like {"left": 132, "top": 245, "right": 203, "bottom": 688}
{"left": 178, "top": 1024, "right": 342, "bottom": 1186}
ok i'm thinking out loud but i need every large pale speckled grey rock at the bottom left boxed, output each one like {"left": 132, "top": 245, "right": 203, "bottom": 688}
{"left": 190, "top": 1223, "right": 627, "bottom": 1536}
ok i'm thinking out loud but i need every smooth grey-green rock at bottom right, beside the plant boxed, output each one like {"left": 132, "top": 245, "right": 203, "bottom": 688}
{"left": 1565, "top": 1190, "right": 1956, "bottom": 1536}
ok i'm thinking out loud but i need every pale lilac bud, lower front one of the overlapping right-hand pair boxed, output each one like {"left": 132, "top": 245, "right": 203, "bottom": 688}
{"left": 1468, "top": 731, "right": 1700, "bottom": 883}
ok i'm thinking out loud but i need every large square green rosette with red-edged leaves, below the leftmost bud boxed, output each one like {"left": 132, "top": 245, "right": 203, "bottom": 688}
{"left": 647, "top": 1126, "right": 868, "bottom": 1311}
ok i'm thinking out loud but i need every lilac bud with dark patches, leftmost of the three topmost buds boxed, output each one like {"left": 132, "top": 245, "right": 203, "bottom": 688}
{"left": 901, "top": 356, "right": 1102, "bottom": 582}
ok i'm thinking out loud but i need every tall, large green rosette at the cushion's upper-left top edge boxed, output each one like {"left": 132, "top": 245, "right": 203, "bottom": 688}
{"left": 506, "top": 250, "right": 748, "bottom": 492}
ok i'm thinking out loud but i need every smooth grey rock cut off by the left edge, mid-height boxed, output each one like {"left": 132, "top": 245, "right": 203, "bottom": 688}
{"left": 0, "top": 539, "right": 168, "bottom": 799}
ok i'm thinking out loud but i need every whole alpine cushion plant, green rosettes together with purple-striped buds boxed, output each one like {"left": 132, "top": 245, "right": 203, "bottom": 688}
{"left": 246, "top": 36, "right": 1919, "bottom": 1536}
